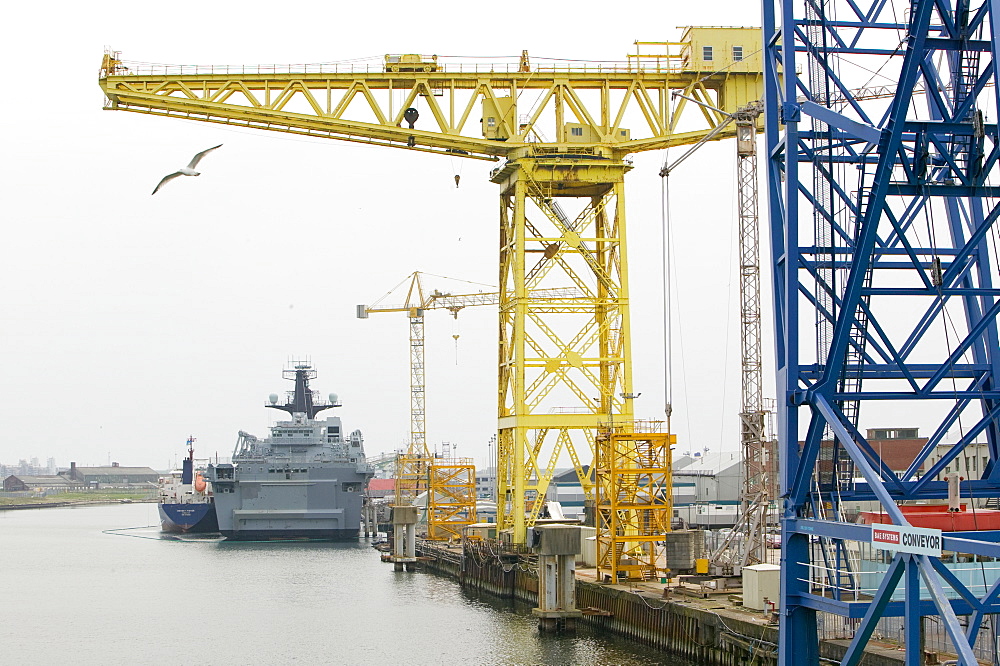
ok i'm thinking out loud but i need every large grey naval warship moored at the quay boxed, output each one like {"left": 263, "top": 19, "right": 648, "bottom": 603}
{"left": 208, "top": 364, "right": 373, "bottom": 541}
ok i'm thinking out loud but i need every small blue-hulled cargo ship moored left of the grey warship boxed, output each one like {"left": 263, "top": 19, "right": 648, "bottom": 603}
{"left": 157, "top": 437, "right": 219, "bottom": 534}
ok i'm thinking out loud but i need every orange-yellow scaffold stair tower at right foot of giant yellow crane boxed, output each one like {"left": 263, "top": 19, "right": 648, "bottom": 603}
{"left": 596, "top": 421, "right": 675, "bottom": 581}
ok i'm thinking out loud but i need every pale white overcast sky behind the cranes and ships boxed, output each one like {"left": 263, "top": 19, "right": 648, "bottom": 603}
{"left": 0, "top": 1, "right": 772, "bottom": 468}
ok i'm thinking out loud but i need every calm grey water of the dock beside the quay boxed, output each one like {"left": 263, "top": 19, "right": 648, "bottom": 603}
{"left": 0, "top": 504, "right": 681, "bottom": 666}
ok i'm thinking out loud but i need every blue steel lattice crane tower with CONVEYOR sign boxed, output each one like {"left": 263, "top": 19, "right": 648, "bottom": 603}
{"left": 763, "top": 0, "right": 1000, "bottom": 665}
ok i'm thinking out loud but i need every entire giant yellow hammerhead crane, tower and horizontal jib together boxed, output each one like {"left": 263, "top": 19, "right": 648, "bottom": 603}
{"left": 100, "top": 27, "right": 763, "bottom": 543}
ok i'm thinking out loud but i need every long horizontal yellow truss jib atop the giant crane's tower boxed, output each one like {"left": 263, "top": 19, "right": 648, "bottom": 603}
{"left": 100, "top": 33, "right": 760, "bottom": 160}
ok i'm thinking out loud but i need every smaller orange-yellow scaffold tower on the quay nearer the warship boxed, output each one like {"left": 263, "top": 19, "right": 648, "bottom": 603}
{"left": 427, "top": 458, "right": 476, "bottom": 541}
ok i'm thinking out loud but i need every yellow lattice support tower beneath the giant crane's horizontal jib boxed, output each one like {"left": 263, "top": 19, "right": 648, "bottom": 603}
{"left": 494, "top": 156, "right": 632, "bottom": 540}
